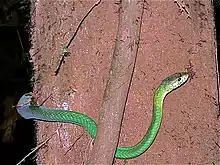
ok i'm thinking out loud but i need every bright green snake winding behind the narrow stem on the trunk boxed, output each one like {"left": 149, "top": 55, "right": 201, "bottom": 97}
{"left": 17, "top": 72, "right": 189, "bottom": 159}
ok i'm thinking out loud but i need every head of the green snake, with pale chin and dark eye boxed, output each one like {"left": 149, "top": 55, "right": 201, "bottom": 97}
{"left": 161, "top": 72, "right": 189, "bottom": 93}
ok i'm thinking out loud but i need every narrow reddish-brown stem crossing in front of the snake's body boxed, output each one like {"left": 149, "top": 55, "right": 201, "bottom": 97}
{"left": 86, "top": 0, "right": 144, "bottom": 164}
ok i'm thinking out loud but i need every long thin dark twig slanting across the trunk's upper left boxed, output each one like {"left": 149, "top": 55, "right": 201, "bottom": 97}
{"left": 55, "top": 0, "right": 101, "bottom": 76}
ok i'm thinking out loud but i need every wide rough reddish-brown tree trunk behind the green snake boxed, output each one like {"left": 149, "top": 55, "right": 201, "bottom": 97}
{"left": 31, "top": 0, "right": 220, "bottom": 165}
